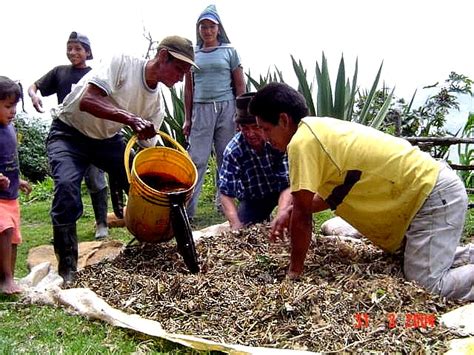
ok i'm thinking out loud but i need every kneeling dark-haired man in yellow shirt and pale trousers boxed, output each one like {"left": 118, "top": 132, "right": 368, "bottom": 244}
{"left": 250, "top": 83, "right": 474, "bottom": 300}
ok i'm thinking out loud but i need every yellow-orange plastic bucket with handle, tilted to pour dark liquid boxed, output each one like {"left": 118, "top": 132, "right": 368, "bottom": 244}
{"left": 124, "top": 132, "right": 197, "bottom": 243}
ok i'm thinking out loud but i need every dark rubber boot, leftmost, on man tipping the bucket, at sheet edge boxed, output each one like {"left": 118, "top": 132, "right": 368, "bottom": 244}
{"left": 53, "top": 223, "right": 79, "bottom": 284}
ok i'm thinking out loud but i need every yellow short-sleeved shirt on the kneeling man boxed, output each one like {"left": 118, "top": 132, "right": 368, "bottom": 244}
{"left": 288, "top": 117, "right": 440, "bottom": 252}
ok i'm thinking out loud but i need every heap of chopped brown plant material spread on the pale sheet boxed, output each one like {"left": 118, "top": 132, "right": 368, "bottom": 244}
{"left": 72, "top": 225, "right": 461, "bottom": 353}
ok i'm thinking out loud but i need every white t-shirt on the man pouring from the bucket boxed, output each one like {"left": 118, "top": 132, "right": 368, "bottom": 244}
{"left": 51, "top": 55, "right": 164, "bottom": 139}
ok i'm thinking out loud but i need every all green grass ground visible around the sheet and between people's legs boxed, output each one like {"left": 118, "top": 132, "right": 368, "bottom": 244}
{"left": 0, "top": 172, "right": 474, "bottom": 355}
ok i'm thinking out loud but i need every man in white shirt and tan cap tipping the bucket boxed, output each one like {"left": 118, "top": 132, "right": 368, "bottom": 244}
{"left": 47, "top": 36, "right": 196, "bottom": 282}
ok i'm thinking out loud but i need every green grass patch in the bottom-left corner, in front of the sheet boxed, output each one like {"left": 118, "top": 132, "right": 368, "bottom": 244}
{"left": 0, "top": 302, "right": 212, "bottom": 354}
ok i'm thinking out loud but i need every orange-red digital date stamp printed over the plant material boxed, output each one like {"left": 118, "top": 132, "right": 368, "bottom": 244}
{"left": 354, "top": 313, "right": 436, "bottom": 329}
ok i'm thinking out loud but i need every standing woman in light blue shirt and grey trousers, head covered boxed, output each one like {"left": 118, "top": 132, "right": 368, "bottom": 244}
{"left": 183, "top": 5, "right": 245, "bottom": 218}
